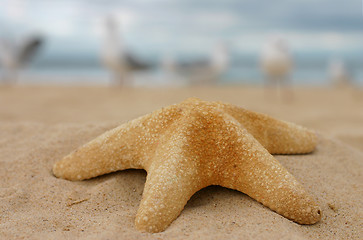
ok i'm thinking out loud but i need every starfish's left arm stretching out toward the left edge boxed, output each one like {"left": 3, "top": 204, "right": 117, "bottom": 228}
{"left": 53, "top": 123, "right": 141, "bottom": 180}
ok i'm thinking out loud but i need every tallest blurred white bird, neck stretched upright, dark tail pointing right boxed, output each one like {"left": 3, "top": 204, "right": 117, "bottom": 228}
{"left": 101, "top": 16, "right": 152, "bottom": 86}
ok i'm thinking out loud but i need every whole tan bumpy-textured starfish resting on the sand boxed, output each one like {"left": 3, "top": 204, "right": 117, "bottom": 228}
{"left": 53, "top": 98, "right": 321, "bottom": 232}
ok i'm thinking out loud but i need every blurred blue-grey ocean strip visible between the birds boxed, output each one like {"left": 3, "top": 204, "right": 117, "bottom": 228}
{"left": 0, "top": 54, "right": 363, "bottom": 87}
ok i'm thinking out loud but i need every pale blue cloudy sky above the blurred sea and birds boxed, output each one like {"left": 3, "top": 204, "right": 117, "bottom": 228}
{"left": 0, "top": 0, "right": 363, "bottom": 64}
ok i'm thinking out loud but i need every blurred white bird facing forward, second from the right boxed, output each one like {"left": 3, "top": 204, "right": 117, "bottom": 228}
{"left": 260, "top": 37, "right": 293, "bottom": 100}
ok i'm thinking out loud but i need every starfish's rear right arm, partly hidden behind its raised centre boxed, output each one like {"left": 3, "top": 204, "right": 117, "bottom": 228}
{"left": 216, "top": 102, "right": 317, "bottom": 154}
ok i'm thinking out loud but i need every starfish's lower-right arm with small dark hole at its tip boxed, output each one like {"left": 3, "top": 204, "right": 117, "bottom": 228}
{"left": 220, "top": 135, "right": 321, "bottom": 224}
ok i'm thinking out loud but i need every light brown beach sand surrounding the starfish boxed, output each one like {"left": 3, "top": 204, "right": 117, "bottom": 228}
{"left": 0, "top": 86, "right": 363, "bottom": 239}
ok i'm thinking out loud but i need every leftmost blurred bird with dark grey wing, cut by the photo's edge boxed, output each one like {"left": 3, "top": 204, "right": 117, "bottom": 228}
{"left": 0, "top": 35, "right": 44, "bottom": 83}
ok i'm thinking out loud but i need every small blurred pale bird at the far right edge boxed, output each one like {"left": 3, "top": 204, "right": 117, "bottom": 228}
{"left": 328, "top": 58, "right": 350, "bottom": 87}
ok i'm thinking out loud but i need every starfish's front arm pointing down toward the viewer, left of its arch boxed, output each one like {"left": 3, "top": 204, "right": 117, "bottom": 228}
{"left": 135, "top": 136, "right": 208, "bottom": 232}
